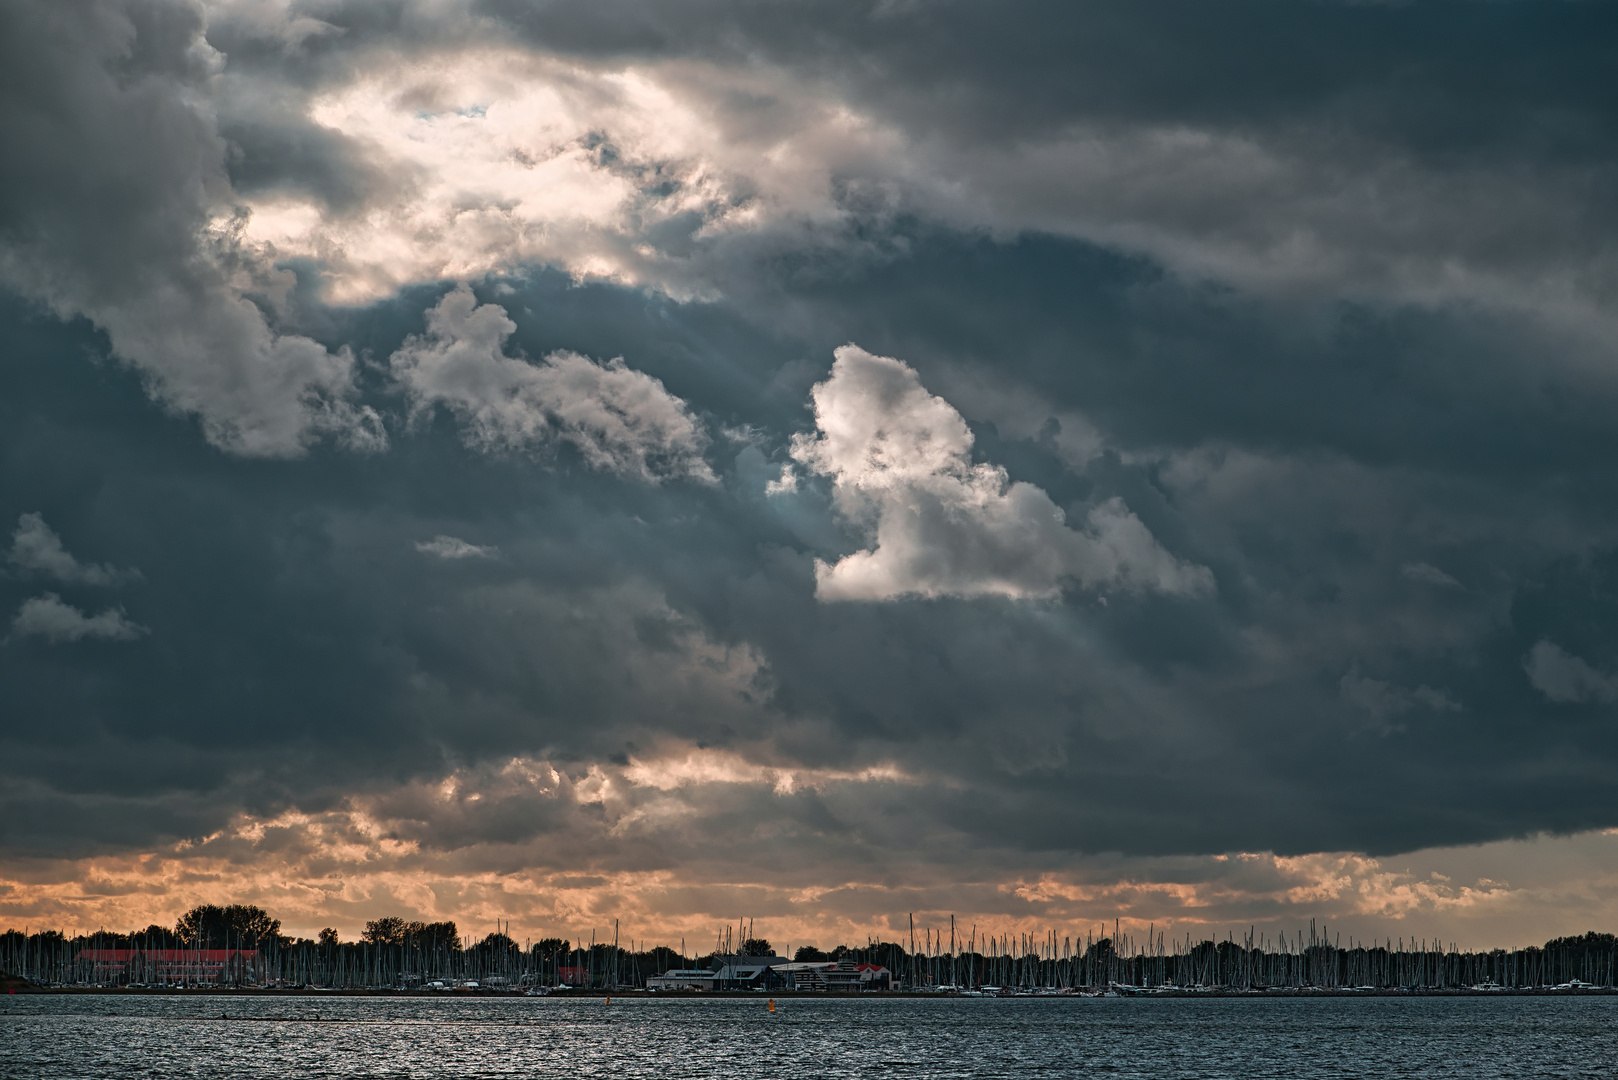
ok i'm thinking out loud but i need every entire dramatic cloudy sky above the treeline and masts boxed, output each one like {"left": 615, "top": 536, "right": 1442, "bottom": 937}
{"left": 0, "top": 0, "right": 1618, "bottom": 946}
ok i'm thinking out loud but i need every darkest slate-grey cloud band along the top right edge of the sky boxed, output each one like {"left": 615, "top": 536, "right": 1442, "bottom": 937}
{"left": 469, "top": 0, "right": 1618, "bottom": 146}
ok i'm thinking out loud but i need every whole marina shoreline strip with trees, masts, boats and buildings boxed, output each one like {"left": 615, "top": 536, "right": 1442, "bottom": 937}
{"left": 0, "top": 920, "right": 1618, "bottom": 997}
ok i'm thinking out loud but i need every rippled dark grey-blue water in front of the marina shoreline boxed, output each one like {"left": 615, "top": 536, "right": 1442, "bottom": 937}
{"left": 0, "top": 994, "right": 1618, "bottom": 1080}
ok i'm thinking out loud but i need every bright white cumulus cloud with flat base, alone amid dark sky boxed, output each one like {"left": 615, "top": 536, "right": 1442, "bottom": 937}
{"left": 791, "top": 345, "right": 1214, "bottom": 601}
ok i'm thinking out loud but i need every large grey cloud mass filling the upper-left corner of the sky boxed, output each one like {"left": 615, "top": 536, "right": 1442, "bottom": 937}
{"left": 0, "top": 0, "right": 380, "bottom": 457}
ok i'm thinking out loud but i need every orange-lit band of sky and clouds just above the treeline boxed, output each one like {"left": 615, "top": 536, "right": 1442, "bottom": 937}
{"left": 0, "top": 755, "right": 1618, "bottom": 955}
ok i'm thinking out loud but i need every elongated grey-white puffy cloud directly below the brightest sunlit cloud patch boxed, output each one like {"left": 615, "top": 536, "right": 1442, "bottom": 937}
{"left": 390, "top": 285, "right": 714, "bottom": 483}
